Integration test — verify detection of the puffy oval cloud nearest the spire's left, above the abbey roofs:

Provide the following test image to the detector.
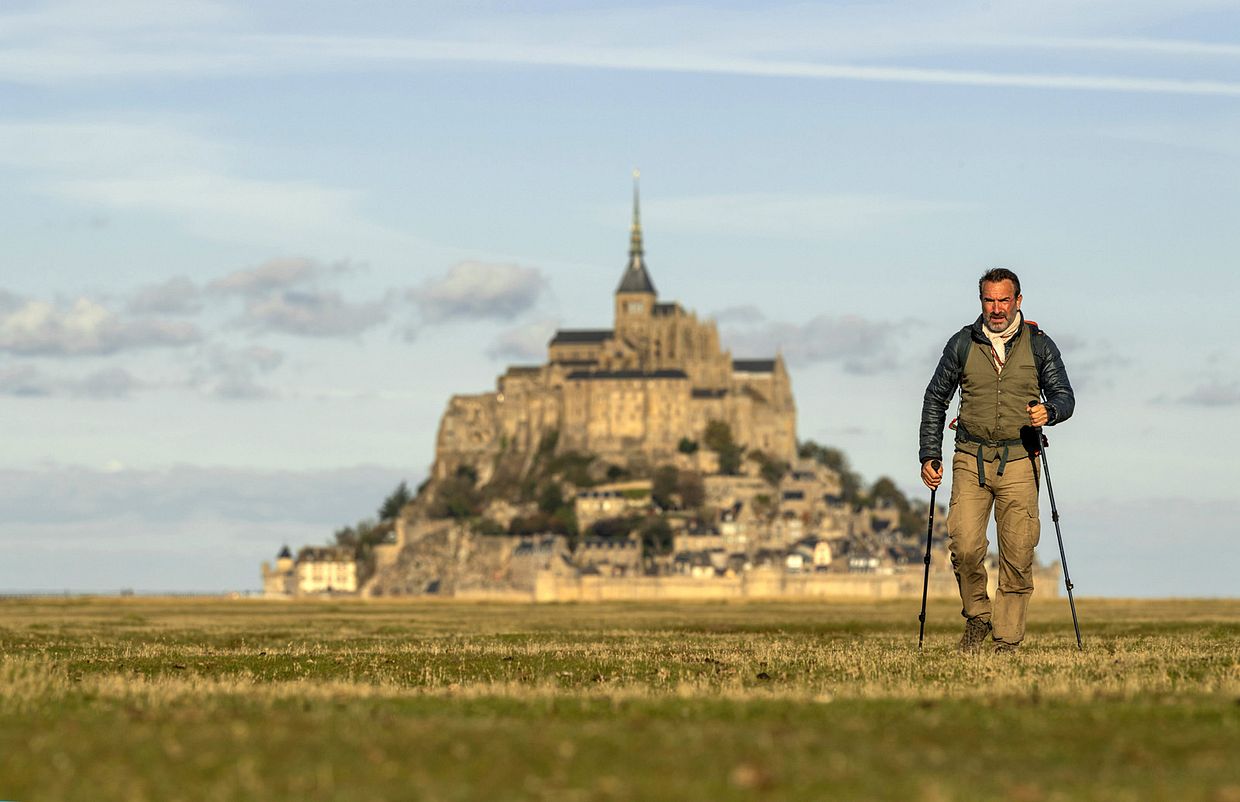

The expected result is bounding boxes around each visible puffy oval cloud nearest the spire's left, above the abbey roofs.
[409,262,547,322]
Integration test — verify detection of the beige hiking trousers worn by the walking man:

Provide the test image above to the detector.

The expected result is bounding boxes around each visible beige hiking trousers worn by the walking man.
[947,451,1042,643]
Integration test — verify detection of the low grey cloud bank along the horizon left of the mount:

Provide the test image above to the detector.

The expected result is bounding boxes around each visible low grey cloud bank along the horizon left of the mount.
[0,466,411,591]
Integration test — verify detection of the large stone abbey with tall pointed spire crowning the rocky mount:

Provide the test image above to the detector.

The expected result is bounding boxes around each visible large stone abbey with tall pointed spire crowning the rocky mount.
[434,178,796,483]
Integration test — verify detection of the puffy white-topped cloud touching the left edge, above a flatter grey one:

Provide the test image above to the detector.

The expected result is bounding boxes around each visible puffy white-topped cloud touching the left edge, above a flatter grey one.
[0,297,201,356]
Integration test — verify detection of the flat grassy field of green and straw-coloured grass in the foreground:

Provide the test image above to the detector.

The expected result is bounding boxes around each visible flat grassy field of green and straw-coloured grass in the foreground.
[0,599,1240,802]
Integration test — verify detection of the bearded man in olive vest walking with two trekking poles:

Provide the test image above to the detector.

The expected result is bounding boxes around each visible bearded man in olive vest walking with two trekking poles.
[919,268,1076,652]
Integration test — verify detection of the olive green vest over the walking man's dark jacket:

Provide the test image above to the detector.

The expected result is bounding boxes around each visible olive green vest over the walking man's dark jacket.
[956,325,1040,461]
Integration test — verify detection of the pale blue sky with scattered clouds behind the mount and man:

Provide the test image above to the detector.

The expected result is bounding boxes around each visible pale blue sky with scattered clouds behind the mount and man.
[0,0,1240,595]
